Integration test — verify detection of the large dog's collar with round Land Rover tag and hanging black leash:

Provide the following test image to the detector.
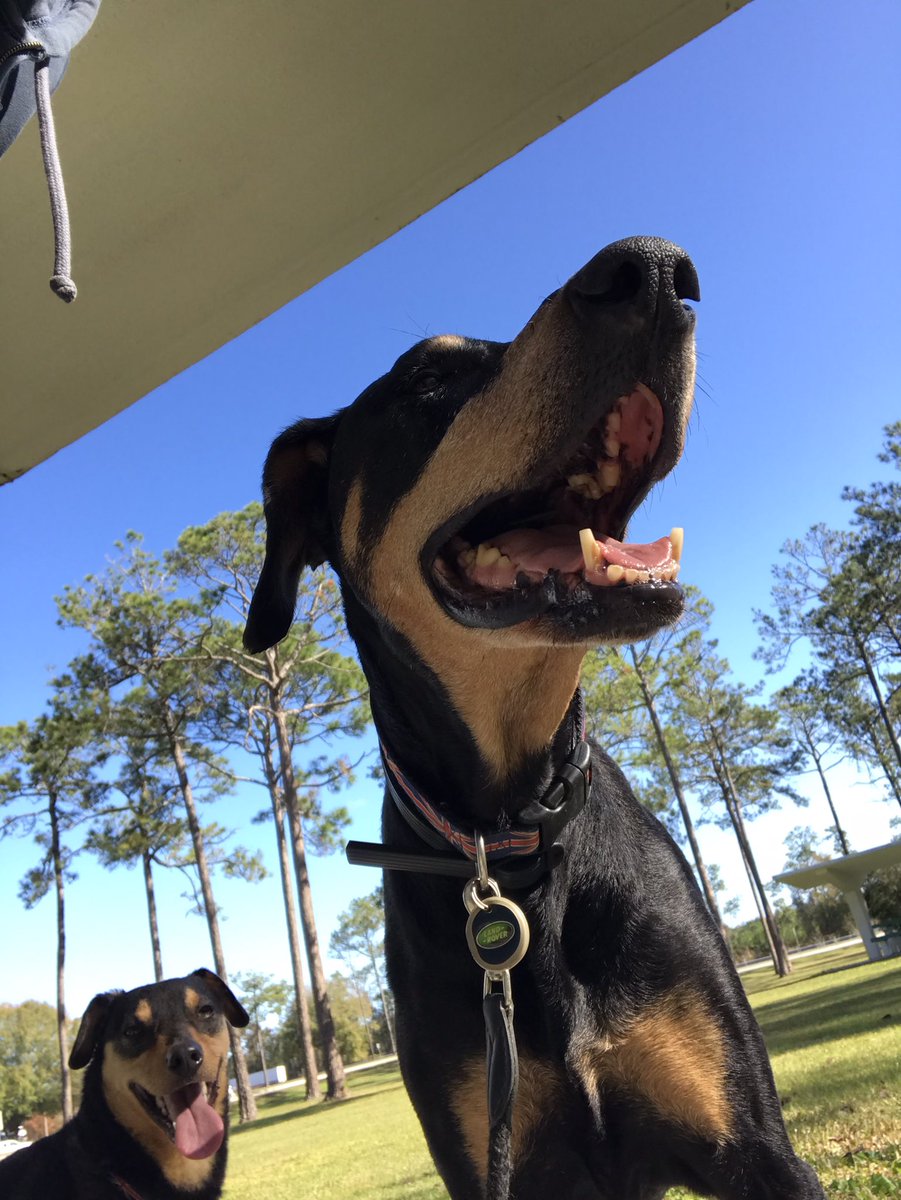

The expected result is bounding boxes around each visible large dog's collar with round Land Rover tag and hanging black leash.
[347,691,591,1200]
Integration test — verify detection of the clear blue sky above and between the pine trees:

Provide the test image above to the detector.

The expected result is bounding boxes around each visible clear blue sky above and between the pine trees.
[0,0,901,1013]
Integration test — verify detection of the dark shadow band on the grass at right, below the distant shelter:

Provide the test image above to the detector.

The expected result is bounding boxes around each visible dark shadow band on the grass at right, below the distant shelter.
[756,968,901,1052]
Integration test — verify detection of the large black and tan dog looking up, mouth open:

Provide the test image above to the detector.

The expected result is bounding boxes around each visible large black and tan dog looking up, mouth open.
[246,238,823,1200]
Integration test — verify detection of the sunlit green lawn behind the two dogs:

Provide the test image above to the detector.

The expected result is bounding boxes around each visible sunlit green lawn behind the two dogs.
[226,948,901,1200]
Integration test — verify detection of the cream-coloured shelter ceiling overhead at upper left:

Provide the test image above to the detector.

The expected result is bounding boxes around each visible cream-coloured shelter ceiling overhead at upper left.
[0,0,744,481]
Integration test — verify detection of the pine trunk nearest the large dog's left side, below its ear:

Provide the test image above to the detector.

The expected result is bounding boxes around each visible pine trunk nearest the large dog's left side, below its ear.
[274,703,347,1100]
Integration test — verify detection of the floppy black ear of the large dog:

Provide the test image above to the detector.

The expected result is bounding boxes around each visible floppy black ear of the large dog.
[244,414,341,654]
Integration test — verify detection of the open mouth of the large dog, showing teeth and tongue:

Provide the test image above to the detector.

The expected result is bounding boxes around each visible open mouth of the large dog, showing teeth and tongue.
[424,383,683,628]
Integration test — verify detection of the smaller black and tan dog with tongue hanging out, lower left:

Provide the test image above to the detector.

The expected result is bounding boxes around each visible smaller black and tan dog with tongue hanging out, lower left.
[0,968,248,1200]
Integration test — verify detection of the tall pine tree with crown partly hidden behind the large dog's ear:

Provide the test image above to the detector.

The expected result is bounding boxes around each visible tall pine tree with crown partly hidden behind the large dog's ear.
[168,504,368,1099]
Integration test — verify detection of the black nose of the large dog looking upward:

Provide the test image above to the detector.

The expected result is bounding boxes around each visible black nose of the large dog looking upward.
[564,238,701,326]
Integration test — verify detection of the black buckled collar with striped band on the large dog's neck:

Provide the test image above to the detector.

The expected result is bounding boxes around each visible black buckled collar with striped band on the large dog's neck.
[347,690,591,888]
